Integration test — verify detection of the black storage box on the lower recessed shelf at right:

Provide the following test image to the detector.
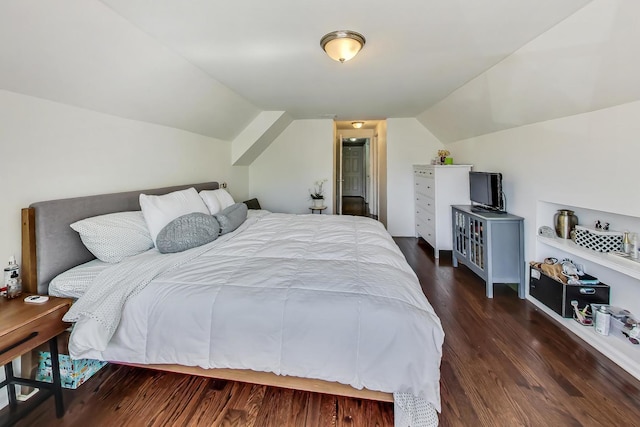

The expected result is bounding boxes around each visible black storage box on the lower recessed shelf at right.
[529,267,610,317]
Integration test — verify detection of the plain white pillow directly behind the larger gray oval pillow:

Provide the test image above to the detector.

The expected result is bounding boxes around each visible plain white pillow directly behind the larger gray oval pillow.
[140,187,209,244]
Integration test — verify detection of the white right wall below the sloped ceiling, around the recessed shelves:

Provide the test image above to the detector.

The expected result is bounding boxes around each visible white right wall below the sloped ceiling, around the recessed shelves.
[447,102,640,313]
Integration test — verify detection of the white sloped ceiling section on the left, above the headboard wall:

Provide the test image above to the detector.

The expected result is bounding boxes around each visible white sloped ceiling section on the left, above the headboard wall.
[0,0,259,140]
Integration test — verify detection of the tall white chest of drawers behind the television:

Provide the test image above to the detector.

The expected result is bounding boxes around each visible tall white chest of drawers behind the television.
[413,165,471,258]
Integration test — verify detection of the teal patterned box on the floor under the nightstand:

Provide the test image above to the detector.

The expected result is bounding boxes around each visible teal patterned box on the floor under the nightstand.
[36,351,107,389]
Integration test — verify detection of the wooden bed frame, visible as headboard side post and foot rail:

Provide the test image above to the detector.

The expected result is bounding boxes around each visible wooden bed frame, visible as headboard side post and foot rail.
[22,185,393,402]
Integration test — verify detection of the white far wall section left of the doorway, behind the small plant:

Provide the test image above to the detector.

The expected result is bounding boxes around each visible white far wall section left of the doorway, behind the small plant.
[249,119,333,213]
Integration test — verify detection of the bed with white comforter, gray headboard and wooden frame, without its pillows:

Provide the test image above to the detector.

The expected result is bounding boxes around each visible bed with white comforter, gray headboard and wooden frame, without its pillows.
[22,182,444,426]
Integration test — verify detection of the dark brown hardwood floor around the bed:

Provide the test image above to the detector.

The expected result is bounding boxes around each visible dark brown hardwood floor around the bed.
[12,238,640,426]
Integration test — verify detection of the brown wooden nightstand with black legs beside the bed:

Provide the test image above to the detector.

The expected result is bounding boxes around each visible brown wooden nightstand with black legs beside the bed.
[0,295,72,425]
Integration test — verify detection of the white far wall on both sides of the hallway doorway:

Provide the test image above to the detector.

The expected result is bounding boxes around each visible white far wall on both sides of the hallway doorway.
[249,118,448,236]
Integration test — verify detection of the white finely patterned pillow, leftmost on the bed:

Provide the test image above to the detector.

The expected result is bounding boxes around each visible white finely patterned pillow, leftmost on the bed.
[71,211,153,263]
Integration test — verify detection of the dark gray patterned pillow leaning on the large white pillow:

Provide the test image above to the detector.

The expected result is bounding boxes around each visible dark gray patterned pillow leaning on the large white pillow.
[156,212,220,254]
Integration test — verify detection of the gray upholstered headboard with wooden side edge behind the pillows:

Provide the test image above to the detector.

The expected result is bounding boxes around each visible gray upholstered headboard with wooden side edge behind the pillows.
[22,182,218,294]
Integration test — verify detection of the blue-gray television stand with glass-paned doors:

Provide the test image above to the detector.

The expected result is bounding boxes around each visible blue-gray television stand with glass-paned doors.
[451,205,526,298]
